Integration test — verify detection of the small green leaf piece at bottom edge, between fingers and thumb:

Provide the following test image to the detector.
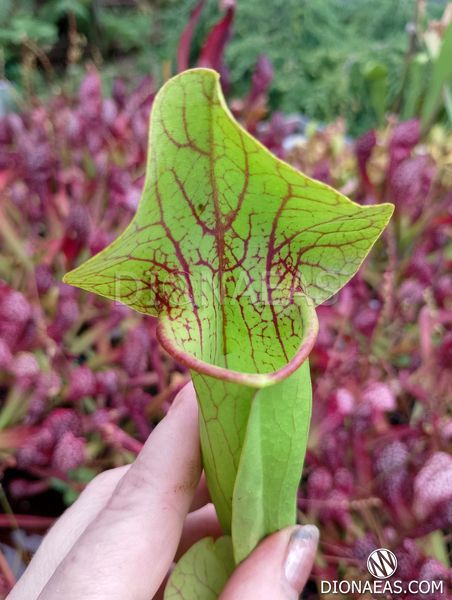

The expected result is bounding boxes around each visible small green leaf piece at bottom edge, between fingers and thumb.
[164,537,234,600]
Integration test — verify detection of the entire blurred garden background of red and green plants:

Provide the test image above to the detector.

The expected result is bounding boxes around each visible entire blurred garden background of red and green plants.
[0,0,452,599]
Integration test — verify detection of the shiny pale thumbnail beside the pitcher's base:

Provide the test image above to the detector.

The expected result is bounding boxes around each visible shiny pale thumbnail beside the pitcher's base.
[284,525,319,593]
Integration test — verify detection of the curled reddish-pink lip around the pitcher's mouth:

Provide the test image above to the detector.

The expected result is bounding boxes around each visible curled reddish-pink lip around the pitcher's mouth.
[157,299,319,388]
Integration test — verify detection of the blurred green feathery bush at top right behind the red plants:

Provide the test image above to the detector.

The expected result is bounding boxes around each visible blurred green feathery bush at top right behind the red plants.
[158,0,445,135]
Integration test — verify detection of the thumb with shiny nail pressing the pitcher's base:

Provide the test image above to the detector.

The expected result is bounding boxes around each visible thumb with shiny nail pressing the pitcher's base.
[220,525,319,600]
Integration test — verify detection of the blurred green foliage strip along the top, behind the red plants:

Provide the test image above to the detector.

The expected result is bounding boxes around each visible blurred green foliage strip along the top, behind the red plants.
[0,0,450,135]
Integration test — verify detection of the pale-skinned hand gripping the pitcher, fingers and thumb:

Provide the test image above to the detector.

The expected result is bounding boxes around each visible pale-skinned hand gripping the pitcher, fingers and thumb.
[7,384,318,600]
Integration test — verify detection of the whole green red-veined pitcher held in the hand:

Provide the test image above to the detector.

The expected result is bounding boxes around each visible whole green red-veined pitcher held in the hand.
[65,69,392,600]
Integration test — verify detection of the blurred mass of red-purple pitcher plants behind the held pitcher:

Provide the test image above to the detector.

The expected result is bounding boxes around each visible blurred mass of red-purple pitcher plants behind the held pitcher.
[0,24,452,596]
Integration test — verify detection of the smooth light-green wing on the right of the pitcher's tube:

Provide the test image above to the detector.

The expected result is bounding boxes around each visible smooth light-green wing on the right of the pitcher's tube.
[232,360,312,563]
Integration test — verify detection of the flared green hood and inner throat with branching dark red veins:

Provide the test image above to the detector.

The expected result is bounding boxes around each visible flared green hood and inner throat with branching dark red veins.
[66,69,392,380]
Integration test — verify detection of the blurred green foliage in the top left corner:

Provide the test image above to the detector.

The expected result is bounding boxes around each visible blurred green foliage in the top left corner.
[0,0,162,95]
